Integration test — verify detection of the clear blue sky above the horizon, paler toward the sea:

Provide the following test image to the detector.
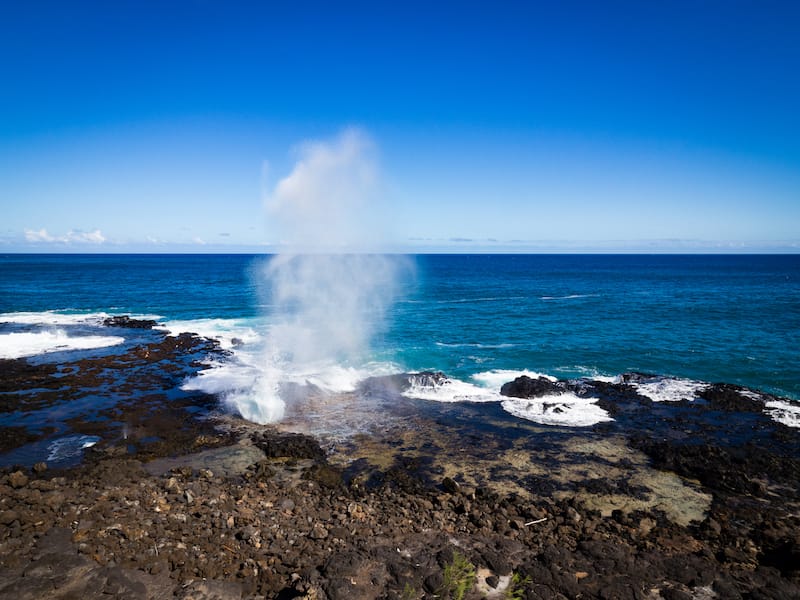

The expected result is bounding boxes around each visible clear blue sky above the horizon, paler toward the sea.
[0,0,800,252]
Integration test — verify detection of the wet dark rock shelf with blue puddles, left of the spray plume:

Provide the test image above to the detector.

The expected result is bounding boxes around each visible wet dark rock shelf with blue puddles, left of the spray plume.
[0,326,231,465]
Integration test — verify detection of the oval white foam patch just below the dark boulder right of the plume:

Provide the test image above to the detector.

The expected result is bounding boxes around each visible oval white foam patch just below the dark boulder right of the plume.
[502,392,613,427]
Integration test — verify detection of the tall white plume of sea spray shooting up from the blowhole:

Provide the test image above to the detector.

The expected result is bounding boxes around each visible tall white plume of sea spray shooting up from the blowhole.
[229,129,410,422]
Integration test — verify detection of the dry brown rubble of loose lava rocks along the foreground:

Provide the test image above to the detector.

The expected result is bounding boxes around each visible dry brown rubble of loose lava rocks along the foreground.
[0,418,800,599]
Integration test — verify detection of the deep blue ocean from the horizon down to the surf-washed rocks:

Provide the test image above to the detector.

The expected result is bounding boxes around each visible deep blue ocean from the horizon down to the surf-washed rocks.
[0,255,800,432]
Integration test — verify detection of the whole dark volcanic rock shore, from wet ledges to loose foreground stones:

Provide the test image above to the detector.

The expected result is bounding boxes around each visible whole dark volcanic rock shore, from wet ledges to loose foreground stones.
[0,321,800,600]
